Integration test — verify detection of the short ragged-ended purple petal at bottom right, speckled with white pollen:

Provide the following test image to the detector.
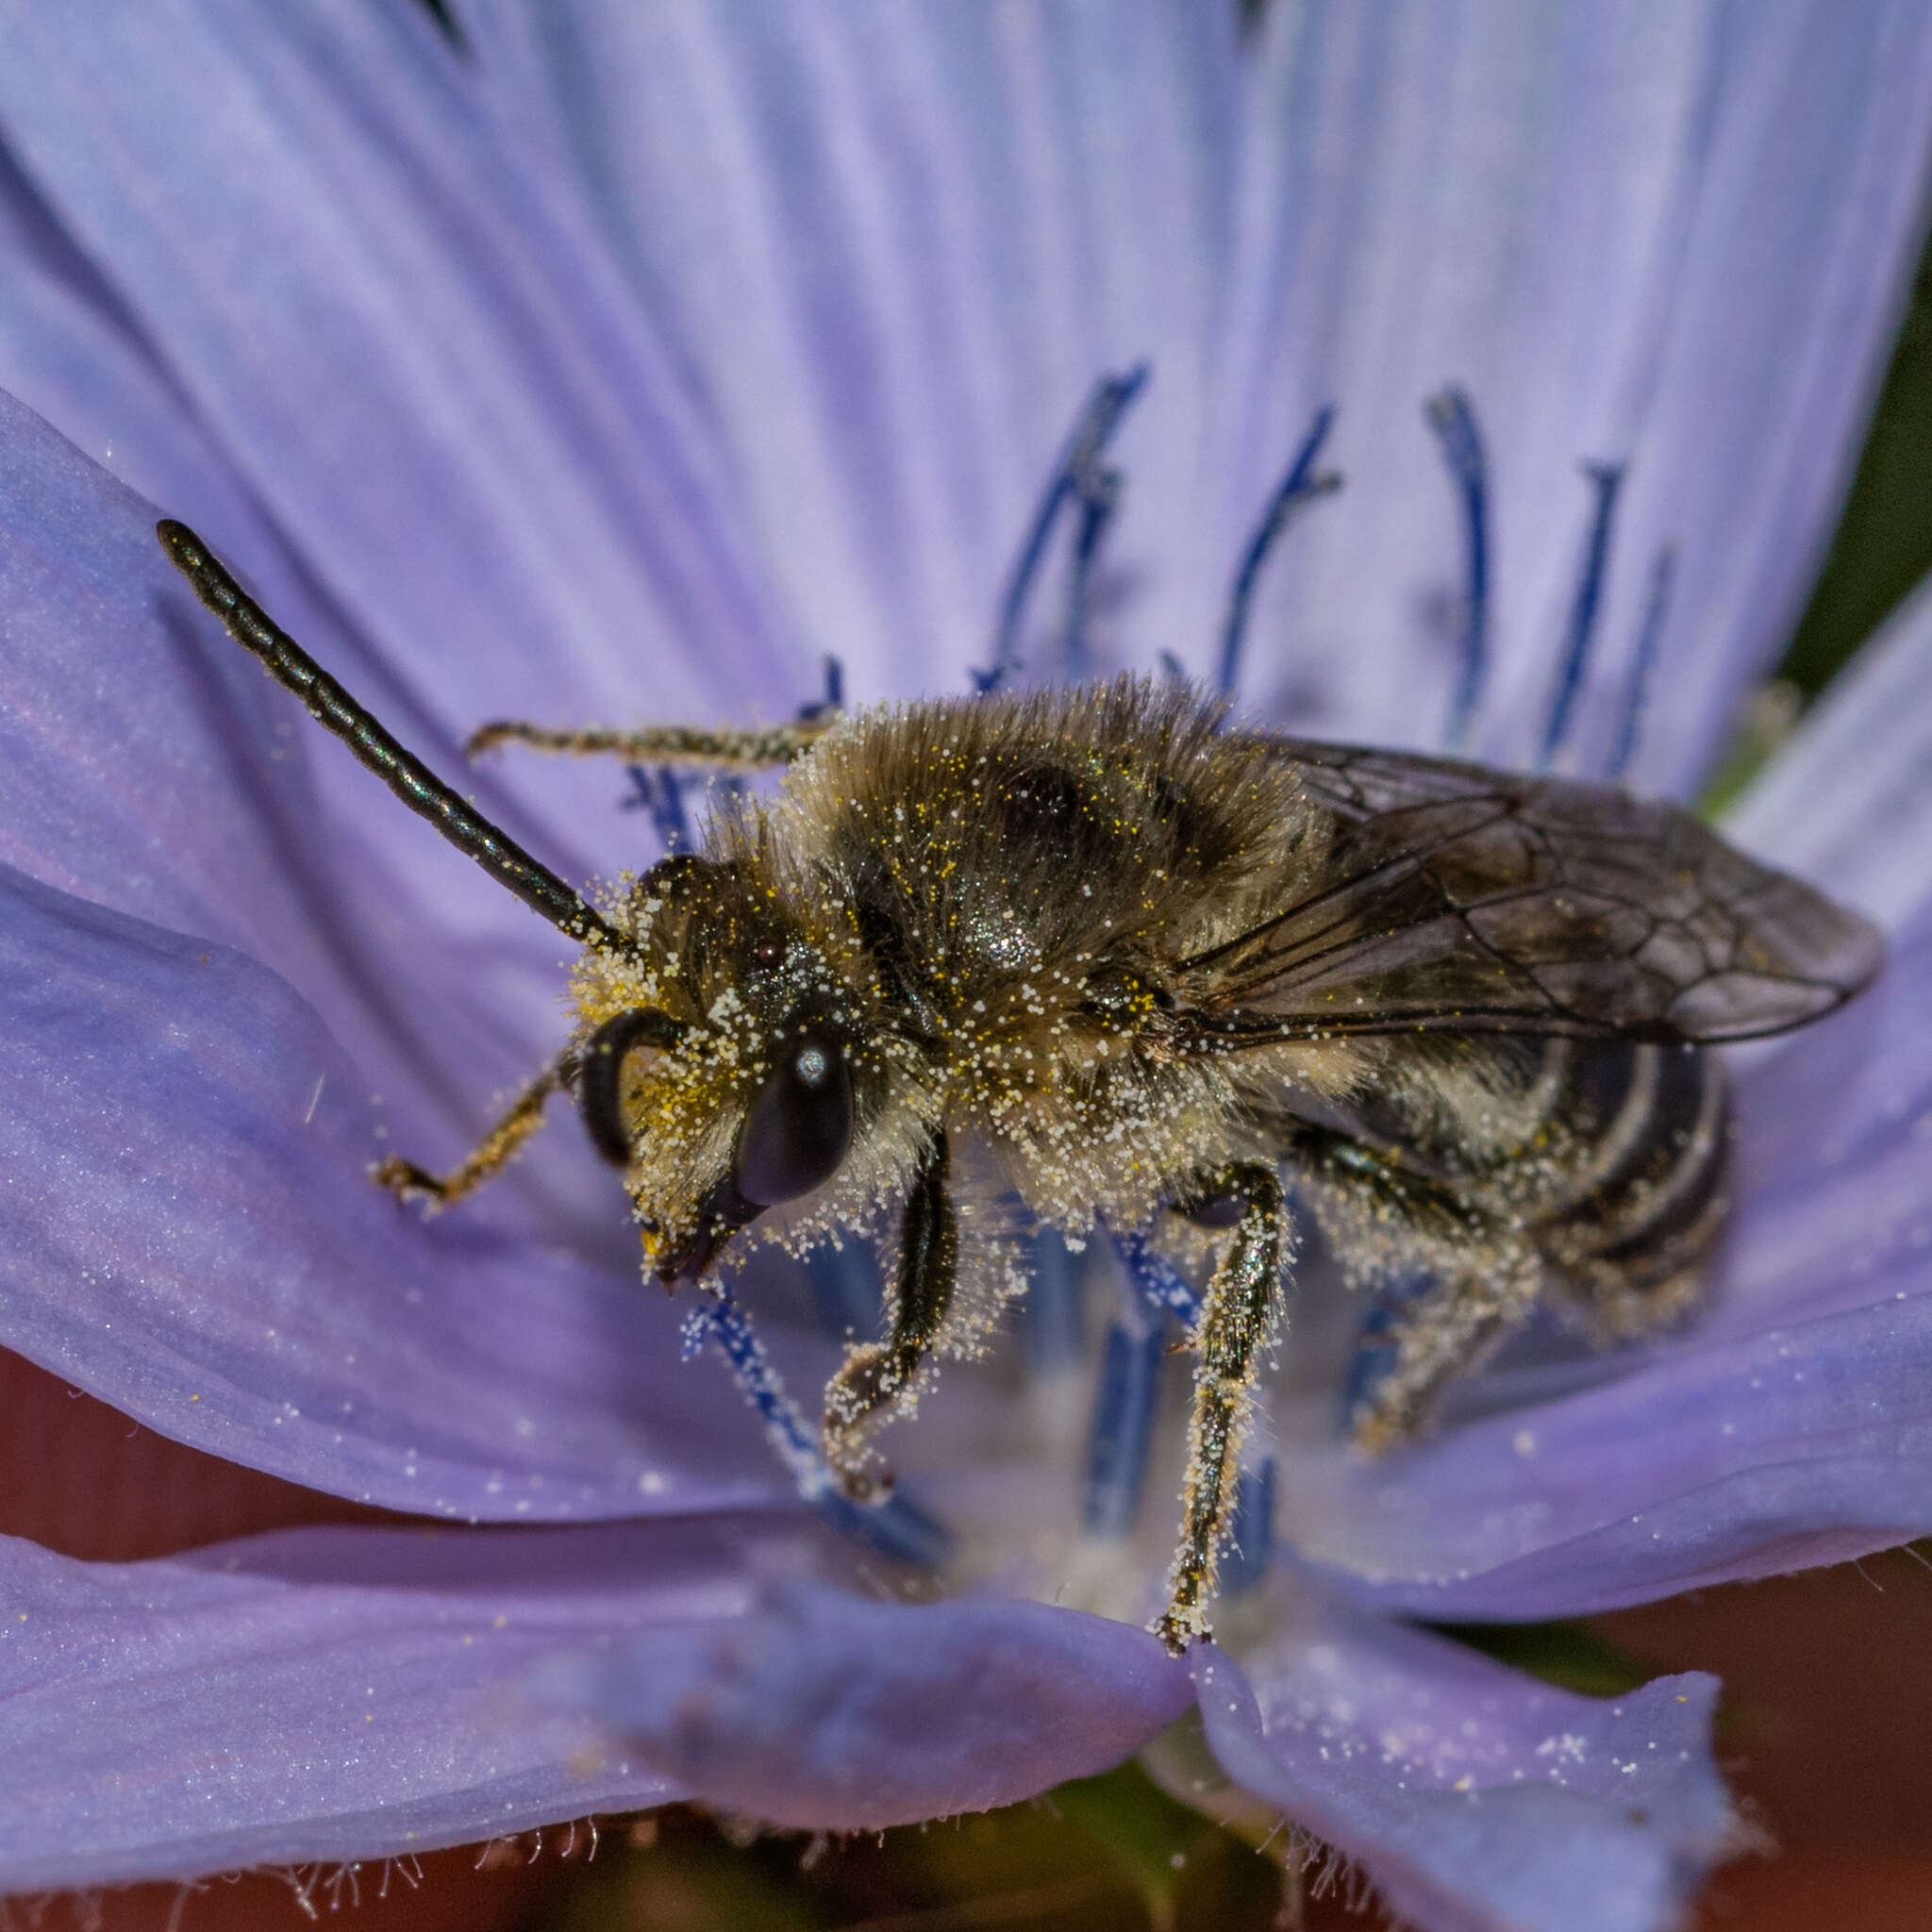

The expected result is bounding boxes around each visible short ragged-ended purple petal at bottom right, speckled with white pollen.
[1194,1611,1731,1932]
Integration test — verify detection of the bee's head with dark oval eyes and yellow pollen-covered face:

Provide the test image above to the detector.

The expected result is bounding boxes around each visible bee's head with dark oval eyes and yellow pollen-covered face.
[574,854,854,1287]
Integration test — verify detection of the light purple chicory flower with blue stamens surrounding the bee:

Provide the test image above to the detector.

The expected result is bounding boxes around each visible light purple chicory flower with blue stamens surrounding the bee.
[0,0,1932,1932]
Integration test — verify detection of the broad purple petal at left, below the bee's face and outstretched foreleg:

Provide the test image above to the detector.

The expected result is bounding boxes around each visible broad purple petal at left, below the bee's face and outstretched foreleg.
[0,872,782,1521]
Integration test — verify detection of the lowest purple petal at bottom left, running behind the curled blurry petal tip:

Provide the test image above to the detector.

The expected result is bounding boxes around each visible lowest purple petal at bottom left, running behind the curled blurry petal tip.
[0,1523,791,1893]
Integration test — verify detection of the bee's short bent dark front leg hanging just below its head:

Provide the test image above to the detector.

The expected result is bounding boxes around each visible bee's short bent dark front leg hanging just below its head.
[821,1128,960,1501]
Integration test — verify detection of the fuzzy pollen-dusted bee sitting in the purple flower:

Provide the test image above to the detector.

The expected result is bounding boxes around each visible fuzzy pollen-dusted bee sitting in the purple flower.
[158,522,1882,1654]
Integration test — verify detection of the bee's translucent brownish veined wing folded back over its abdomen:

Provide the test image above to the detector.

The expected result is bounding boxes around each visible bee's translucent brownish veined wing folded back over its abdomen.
[1182,738,1884,1045]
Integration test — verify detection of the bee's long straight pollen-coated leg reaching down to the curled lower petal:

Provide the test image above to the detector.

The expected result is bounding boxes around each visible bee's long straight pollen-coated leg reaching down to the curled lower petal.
[1154,1163,1289,1657]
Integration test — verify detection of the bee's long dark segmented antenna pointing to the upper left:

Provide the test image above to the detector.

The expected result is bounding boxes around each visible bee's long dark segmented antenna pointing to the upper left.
[155,518,628,951]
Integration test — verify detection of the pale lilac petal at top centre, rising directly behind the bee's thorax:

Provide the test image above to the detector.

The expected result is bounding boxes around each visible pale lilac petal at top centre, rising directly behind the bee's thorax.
[466,0,1239,701]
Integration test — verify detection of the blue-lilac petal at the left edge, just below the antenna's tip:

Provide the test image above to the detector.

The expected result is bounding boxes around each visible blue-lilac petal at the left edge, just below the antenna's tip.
[0,394,359,1042]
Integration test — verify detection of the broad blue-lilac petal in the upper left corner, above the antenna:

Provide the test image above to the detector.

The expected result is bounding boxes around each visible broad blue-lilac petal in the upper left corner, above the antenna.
[0,0,799,738]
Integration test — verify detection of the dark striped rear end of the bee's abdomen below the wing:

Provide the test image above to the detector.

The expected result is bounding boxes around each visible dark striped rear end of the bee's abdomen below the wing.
[1532,1045,1731,1335]
